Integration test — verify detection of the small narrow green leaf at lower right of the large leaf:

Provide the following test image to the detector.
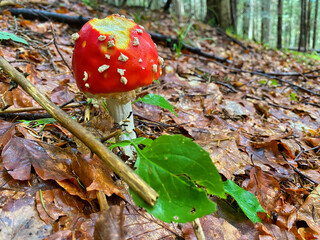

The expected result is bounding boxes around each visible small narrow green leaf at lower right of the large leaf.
[224,180,266,223]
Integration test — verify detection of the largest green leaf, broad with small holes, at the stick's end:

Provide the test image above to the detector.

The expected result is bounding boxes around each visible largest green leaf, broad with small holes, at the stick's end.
[131,135,225,223]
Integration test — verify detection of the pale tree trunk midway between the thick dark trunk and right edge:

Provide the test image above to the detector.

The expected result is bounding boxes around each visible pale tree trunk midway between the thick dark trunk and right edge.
[261,1,271,43]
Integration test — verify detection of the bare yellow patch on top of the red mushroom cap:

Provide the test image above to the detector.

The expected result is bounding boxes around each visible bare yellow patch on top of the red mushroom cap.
[90,15,136,49]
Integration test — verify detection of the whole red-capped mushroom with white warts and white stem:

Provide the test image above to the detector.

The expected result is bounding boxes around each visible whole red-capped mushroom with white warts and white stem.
[72,14,163,158]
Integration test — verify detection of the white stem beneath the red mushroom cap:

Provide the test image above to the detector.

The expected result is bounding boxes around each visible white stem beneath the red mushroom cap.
[106,98,137,159]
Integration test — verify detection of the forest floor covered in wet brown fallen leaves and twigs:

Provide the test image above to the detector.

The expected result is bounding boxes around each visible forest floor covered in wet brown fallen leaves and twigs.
[0,0,320,239]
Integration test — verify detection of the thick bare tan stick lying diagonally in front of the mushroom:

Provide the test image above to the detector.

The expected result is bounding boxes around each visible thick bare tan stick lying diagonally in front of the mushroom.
[0,56,158,206]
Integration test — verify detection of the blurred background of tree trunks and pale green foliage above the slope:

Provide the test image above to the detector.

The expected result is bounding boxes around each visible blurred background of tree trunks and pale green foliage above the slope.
[99,0,320,51]
